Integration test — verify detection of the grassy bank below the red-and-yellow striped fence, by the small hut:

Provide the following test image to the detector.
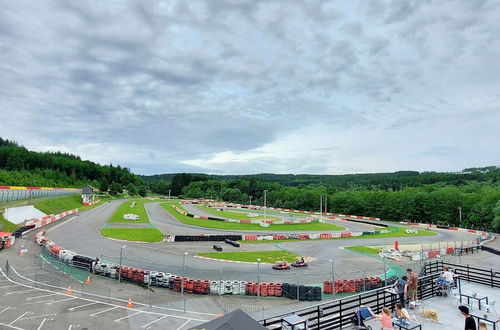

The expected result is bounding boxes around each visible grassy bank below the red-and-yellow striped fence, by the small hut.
[33,194,113,214]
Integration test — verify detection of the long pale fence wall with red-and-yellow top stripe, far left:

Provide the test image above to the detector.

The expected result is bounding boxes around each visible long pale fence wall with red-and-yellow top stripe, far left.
[0,186,82,203]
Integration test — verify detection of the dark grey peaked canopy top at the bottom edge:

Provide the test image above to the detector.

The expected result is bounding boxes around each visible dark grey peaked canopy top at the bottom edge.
[191,309,267,330]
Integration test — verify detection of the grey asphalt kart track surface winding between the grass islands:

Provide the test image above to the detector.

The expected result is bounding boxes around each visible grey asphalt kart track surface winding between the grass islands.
[41,200,478,283]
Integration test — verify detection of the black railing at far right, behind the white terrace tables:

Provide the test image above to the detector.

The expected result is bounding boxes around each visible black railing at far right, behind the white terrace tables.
[423,260,500,288]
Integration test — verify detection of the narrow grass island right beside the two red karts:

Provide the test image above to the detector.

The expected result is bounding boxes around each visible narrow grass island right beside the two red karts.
[198,251,299,263]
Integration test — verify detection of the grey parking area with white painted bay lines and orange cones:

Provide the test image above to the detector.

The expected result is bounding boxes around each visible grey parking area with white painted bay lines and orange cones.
[0,275,213,330]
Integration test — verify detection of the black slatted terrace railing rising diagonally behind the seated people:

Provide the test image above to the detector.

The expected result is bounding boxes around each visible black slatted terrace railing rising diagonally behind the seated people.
[259,272,444,330]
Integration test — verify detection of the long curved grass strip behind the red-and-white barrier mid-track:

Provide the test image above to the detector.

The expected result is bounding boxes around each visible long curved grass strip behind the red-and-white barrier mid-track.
[160,203,344,231]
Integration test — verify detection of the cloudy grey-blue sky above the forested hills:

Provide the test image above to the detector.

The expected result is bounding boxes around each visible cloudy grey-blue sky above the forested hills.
[0,0,500,174]
